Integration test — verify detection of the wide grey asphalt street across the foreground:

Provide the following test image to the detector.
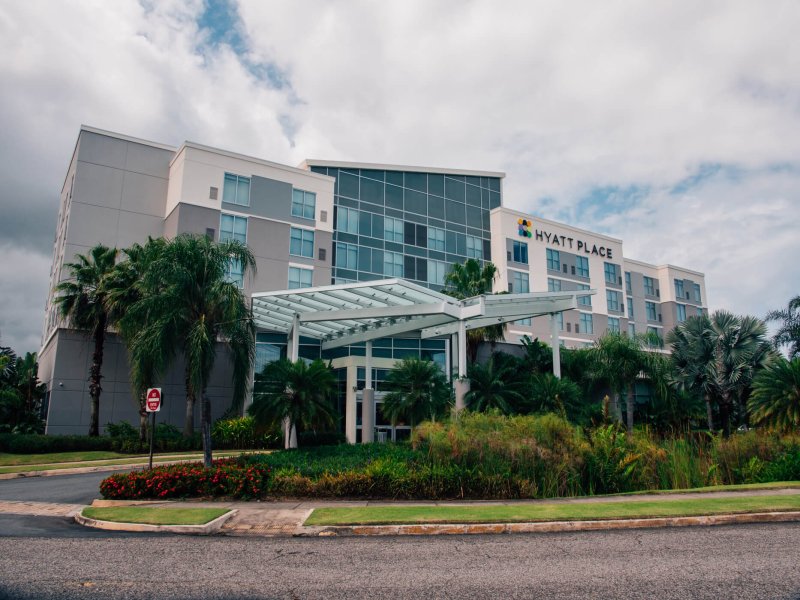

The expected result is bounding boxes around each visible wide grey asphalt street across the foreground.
[0,524,800,600]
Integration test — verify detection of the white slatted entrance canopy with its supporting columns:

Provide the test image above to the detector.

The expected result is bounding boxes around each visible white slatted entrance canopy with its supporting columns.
[252,279,595,441]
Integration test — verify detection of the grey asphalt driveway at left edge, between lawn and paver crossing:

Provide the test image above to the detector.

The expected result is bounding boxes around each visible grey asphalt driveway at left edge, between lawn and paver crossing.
[0,471,122,504]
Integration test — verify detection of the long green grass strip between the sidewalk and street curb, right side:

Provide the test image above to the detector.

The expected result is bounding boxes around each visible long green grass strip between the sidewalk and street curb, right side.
[305,494,800,525]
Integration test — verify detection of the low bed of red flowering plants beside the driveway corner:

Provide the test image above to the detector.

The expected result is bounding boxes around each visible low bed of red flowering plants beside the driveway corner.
[100,458,271,500]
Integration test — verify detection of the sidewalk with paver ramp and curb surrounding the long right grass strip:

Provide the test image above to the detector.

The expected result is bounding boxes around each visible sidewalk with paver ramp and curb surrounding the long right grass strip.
[65,488,800,537]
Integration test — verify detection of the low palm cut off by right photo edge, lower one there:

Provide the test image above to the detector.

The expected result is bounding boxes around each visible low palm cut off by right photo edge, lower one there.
[747,356,800,430]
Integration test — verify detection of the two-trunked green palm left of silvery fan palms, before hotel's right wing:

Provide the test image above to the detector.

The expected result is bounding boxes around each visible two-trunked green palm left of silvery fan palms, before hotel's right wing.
[594,332,648,436]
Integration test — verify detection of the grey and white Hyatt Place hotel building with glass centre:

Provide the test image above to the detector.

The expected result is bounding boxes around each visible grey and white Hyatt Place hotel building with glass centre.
[39,127,706,441]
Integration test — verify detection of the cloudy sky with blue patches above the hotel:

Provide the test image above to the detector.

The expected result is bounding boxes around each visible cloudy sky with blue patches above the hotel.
[0,0,800,352]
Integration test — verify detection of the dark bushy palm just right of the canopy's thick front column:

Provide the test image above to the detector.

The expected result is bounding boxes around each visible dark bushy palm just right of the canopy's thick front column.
[465,352,524,415]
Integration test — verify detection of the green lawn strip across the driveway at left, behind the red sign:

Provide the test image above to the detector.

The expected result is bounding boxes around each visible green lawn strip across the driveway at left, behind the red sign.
[0,450,253,473]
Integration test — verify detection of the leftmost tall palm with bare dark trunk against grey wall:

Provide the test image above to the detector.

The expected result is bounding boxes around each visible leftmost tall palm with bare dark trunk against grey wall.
[55,245,117,436]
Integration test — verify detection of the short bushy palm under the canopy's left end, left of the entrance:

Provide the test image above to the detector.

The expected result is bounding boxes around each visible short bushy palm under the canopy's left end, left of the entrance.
[248,358,336,447]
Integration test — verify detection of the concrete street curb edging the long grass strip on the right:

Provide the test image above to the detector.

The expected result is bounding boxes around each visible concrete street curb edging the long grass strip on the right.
[294,511,800,537]
